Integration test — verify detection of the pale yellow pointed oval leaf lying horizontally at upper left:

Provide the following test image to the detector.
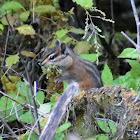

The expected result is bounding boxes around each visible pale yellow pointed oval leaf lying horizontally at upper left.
[16,25,35,35]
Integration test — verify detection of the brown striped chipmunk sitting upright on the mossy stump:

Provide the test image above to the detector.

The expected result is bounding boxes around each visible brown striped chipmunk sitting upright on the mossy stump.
[42,40,102,92]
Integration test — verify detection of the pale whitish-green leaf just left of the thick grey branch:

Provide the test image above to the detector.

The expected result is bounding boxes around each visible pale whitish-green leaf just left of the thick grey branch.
[38,103,52,114]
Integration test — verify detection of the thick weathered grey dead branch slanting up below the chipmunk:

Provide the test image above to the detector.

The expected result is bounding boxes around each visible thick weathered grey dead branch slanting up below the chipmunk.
[39,83,78,140]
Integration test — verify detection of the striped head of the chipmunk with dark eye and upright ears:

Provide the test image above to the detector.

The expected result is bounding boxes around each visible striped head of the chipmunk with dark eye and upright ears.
[42,40,72,67]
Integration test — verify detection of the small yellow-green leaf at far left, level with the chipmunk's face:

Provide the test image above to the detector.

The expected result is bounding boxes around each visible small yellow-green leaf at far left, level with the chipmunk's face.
[6,54,19,67]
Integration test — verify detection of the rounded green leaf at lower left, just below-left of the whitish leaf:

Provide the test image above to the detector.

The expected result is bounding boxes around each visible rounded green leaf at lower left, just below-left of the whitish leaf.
[20,111,33,124]
